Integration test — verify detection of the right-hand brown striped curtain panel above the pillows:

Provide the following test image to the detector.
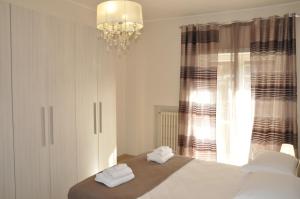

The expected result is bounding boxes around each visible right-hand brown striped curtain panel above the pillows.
[250,15,298,157]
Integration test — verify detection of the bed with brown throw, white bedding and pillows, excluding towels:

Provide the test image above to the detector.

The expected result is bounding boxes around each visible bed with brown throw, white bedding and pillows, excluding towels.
[68,152,300,199]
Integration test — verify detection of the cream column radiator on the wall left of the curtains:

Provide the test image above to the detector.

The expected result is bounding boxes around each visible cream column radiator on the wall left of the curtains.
[158,111,178,151]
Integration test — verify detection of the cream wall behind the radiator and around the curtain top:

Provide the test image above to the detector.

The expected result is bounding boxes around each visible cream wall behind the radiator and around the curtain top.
[119,2,300,155]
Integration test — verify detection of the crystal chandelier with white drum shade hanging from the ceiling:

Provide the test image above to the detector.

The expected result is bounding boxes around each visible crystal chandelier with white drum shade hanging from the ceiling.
[97,0,143,50]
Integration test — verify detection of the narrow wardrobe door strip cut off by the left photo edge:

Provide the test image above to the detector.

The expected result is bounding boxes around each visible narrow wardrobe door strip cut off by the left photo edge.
[0,2,15,199]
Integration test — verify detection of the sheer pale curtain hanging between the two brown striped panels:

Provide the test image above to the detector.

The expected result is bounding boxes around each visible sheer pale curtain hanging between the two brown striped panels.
[216,23,253,165]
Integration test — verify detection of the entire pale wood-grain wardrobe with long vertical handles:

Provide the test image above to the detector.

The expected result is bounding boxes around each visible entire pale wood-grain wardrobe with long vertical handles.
[0,3,116,199]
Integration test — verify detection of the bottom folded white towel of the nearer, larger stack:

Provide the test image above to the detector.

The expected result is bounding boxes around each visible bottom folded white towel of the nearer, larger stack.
[95,172,134,188]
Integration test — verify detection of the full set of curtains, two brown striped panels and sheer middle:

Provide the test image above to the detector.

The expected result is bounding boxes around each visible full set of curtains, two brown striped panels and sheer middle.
[178,15,298,165]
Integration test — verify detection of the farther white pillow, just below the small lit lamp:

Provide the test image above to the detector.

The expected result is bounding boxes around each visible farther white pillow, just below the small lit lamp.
[242,151,298,175]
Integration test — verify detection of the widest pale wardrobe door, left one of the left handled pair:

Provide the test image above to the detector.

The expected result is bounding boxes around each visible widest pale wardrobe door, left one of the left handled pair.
[11,6,50,199]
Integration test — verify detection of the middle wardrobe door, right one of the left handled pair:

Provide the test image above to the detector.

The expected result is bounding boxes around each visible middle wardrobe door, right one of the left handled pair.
[48,17,77,199]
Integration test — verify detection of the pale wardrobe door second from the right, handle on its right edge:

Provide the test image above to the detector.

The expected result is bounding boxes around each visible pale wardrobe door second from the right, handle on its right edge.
[75,25,99,181]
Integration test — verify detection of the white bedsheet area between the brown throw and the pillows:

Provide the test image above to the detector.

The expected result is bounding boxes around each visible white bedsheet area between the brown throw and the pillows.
[139,160,246,199]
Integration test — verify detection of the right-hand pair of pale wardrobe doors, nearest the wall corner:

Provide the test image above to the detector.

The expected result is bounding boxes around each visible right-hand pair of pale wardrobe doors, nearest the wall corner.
[75,25,117,180]
